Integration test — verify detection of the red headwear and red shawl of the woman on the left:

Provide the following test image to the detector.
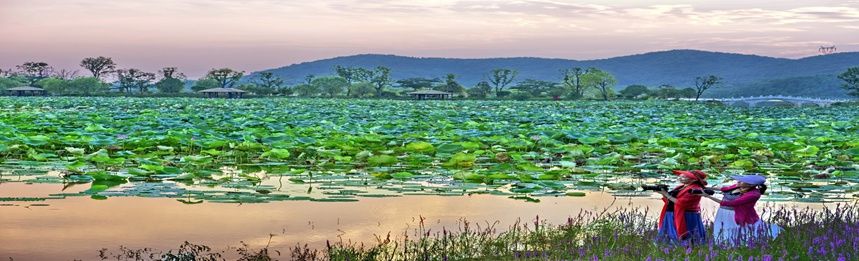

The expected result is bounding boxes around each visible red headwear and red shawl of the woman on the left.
[659,170,707,238]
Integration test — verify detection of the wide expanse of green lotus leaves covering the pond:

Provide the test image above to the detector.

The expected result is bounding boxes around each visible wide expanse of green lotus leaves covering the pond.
[0,98,859,206]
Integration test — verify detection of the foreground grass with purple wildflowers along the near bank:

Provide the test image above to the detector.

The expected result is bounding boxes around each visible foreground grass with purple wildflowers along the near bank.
[95,204,859,261]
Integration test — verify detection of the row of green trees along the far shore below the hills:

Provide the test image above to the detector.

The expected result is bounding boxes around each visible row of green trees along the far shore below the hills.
[0,56,859,100]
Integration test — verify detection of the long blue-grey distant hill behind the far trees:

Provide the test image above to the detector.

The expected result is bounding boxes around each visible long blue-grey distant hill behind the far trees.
[251,50,859,97]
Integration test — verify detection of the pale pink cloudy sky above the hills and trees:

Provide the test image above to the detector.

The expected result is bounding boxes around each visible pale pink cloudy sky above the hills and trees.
[0,0,859,78]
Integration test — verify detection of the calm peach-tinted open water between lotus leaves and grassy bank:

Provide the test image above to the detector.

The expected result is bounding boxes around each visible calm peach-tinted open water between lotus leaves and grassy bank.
[0,183,832,260]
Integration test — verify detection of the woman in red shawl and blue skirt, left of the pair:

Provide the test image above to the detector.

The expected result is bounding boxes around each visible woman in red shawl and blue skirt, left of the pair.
[657,170,707,243]
